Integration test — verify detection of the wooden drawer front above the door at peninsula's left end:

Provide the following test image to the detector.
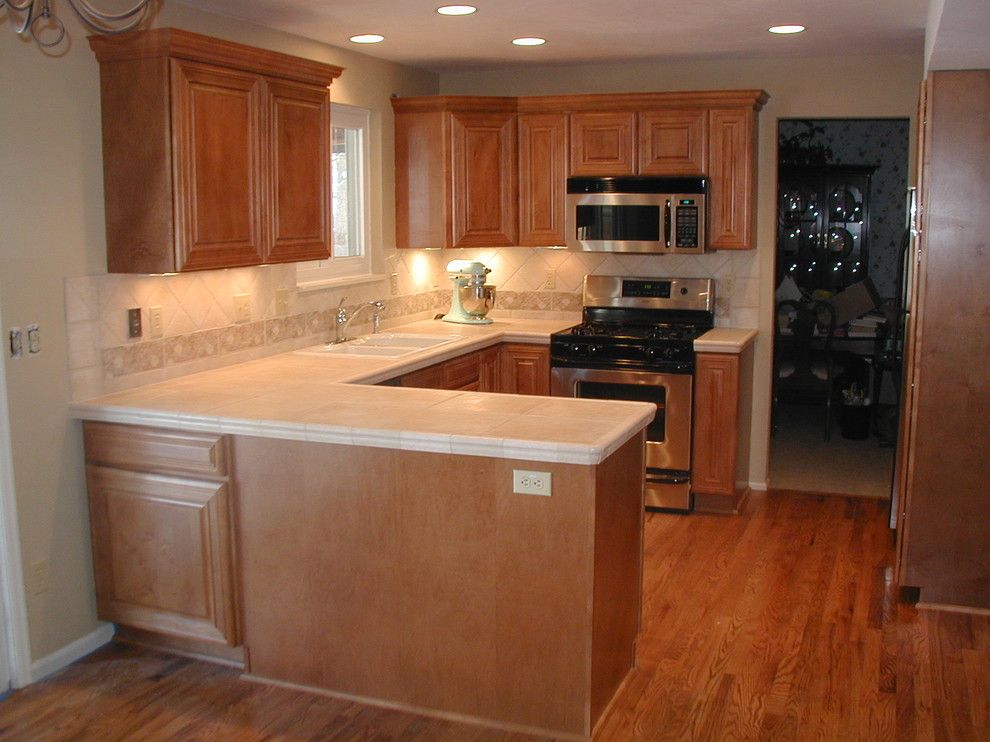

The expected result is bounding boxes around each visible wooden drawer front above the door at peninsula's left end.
[83,422,227,477]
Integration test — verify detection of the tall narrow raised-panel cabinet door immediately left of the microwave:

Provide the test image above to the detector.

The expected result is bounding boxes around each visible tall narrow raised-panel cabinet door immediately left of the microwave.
[517,113,567,247]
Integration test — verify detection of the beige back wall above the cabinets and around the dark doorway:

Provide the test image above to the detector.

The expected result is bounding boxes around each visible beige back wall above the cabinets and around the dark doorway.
[440,52,924,483]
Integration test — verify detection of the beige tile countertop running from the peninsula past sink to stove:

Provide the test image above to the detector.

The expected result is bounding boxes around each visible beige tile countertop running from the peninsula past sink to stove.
[71,319,655,465]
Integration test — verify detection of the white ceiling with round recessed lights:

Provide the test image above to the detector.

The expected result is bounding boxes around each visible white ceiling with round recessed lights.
[174,0,932,72]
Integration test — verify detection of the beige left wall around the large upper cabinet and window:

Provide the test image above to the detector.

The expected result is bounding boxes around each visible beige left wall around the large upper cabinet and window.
[0,3,438,660]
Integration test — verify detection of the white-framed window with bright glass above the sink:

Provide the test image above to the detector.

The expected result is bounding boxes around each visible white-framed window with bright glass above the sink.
[296,103,371,287]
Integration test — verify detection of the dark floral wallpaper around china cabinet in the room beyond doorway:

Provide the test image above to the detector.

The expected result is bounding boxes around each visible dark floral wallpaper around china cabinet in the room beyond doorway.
[778,119,909,298]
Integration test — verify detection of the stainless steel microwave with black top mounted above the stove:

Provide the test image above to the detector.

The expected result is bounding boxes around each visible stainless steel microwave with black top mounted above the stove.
[564,176,708,255]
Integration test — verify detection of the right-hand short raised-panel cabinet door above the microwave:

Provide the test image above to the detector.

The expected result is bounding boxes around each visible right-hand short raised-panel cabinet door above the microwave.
[639,109,708,175]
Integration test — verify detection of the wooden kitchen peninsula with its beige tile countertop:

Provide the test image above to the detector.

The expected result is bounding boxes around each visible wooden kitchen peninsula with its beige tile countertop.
[73,320,654,739]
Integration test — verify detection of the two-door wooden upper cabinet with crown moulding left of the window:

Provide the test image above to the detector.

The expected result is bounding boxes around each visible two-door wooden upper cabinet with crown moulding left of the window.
[89,29,341,273]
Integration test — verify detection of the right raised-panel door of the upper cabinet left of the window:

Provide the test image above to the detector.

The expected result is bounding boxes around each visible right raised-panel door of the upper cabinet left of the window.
[265,80,330,262]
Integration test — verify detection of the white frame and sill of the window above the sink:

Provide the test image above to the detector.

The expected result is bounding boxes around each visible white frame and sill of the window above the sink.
[296,103,381,289]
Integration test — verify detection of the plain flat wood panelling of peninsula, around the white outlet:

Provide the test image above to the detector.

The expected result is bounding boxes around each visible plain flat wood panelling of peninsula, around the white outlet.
[233,434,644,738]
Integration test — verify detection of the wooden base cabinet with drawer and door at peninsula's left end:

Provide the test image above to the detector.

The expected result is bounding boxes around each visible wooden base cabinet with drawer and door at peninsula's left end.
[84,422,239,659]
